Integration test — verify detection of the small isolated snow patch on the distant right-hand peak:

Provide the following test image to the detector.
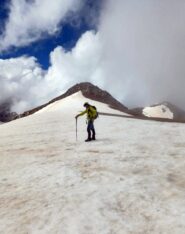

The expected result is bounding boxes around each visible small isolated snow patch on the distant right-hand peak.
[143,105,173,119]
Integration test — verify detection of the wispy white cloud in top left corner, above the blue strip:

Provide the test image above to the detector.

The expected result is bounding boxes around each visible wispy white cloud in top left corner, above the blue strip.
[0,0,82,51]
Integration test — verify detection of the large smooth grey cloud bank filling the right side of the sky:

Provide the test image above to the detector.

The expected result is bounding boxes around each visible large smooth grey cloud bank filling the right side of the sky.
[99,0,185,108]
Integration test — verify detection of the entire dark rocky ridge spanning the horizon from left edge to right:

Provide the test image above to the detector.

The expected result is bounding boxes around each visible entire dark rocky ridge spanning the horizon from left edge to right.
[0,82,185,123]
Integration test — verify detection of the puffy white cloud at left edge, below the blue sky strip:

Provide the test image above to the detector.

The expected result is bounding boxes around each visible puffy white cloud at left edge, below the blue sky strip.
[0,56,48,112]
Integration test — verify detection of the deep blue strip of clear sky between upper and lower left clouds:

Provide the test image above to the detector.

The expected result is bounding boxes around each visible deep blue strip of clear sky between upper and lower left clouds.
[0,23,93,69]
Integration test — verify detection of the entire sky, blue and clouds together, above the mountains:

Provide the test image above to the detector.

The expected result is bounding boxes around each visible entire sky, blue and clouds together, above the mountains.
[0,0,185,113]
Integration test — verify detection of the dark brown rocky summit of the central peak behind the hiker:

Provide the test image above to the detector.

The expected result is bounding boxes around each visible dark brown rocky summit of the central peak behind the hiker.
[16,82,129,118]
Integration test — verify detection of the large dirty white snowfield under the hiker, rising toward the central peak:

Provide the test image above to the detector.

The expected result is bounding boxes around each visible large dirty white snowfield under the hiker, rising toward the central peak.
[0,93,185,234]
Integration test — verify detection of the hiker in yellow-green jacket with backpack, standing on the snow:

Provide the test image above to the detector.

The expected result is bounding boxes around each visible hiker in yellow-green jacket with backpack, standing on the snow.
[75,102,97,142]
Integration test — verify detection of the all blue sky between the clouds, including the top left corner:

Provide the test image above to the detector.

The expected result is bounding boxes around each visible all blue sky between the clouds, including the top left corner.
[0,0,102,69]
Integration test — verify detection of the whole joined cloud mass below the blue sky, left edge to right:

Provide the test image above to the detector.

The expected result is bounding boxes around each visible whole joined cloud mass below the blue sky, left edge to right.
[0,0,185,112]
